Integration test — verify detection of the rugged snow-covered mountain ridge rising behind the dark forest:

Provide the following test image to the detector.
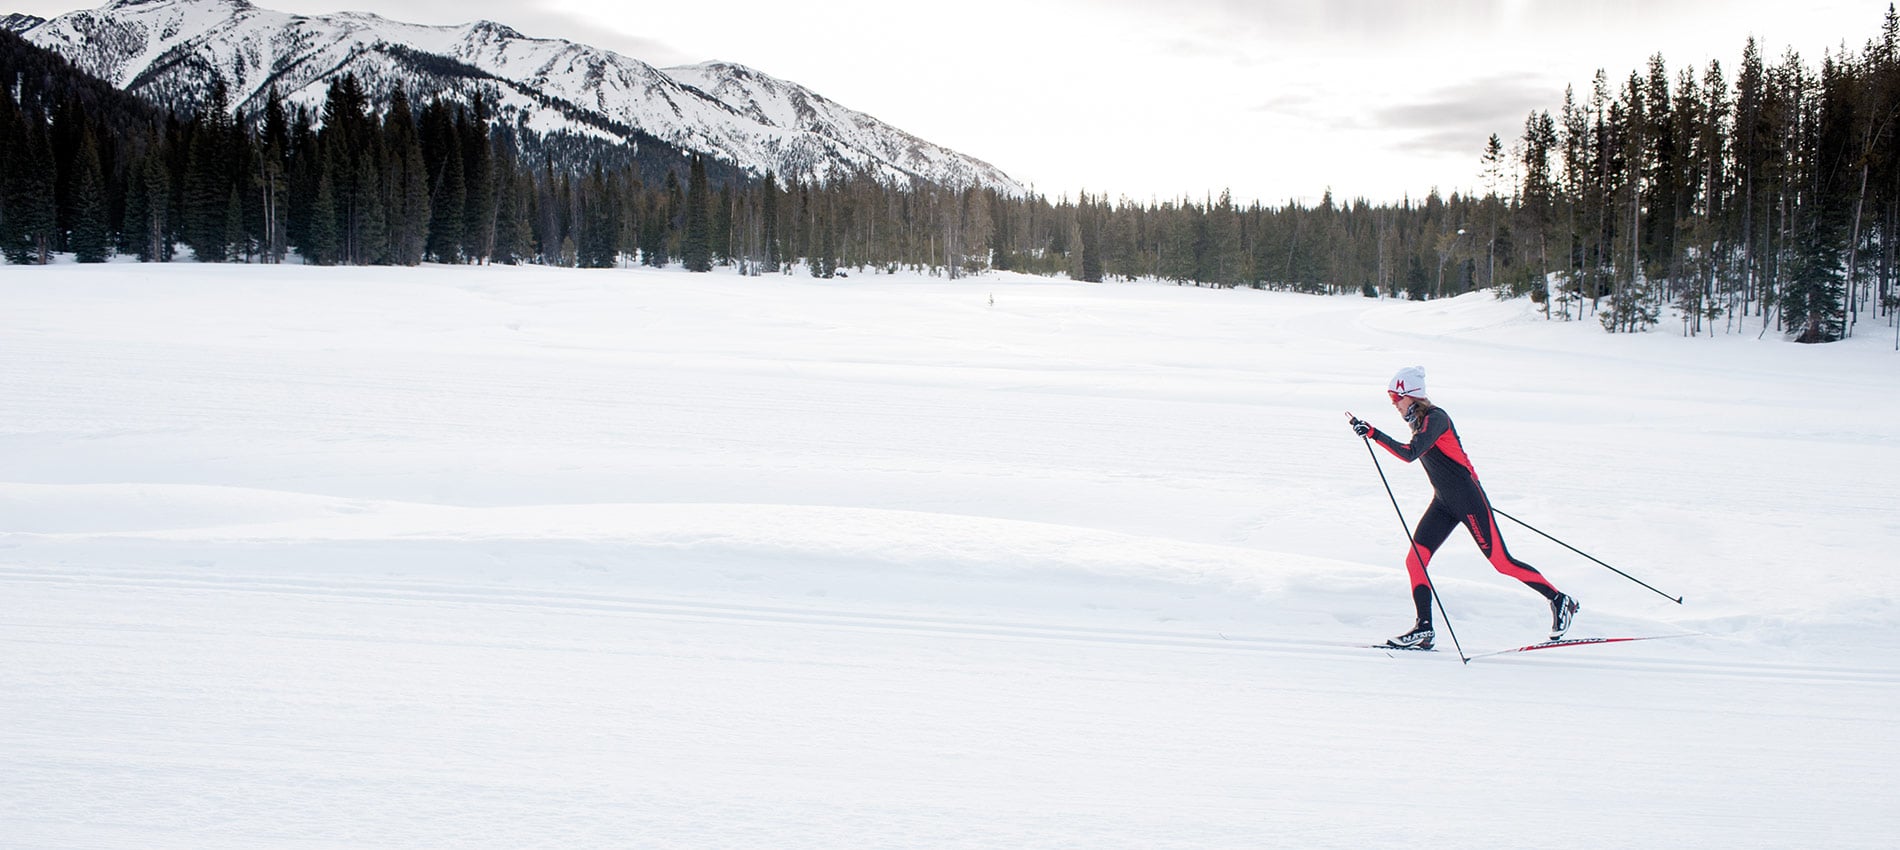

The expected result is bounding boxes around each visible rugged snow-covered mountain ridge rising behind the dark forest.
[6,0,1022,194]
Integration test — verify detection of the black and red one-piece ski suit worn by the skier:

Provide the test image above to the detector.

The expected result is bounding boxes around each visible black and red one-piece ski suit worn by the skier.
[1372,403,1558,626]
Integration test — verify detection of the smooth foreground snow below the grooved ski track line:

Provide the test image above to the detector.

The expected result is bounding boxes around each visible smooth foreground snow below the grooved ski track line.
[0,569,1900,848]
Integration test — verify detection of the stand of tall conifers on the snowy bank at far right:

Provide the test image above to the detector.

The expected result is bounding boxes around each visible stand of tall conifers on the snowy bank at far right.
[1489,6,1900,342]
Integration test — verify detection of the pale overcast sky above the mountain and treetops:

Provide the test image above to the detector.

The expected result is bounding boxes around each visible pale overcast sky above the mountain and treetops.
[14,0,1889,203]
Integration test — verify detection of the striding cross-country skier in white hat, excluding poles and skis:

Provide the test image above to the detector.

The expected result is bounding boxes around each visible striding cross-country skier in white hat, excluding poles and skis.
[1349,365,1577,648]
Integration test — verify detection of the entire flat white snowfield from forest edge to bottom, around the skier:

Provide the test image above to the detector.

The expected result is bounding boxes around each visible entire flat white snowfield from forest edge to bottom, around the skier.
[0,264,1900,850]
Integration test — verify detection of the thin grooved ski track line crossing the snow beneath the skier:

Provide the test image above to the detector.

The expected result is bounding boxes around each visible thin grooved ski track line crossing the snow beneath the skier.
[0,567,1900,685]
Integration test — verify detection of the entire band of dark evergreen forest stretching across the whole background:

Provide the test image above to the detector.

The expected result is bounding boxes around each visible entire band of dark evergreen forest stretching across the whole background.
[0,8,1900,342]
